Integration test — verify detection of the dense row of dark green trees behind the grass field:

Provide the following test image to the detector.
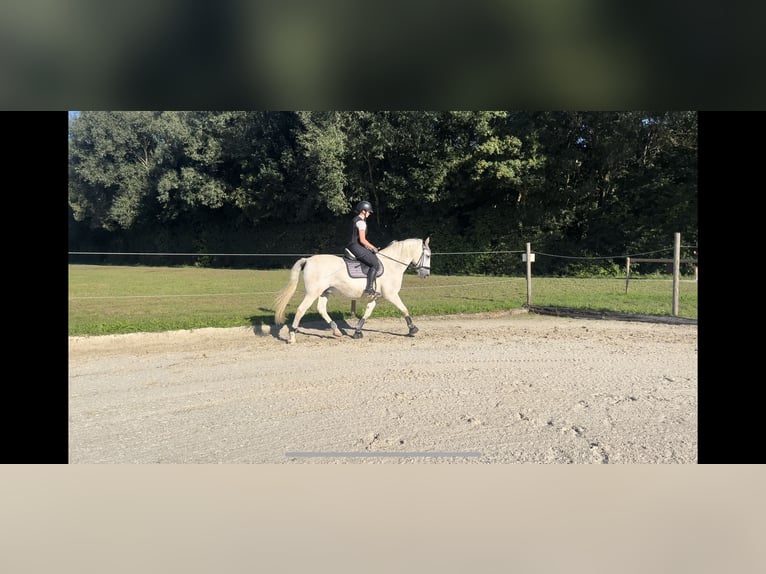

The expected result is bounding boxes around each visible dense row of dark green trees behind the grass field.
[68,111,698,274]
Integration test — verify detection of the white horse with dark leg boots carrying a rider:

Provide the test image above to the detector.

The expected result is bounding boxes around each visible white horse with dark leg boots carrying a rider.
[274,238,431,343]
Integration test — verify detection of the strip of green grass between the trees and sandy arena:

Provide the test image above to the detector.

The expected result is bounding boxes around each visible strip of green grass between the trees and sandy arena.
[69,265,697,336]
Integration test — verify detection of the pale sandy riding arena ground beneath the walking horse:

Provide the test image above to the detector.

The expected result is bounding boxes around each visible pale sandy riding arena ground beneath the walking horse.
[69,313,697,464]
